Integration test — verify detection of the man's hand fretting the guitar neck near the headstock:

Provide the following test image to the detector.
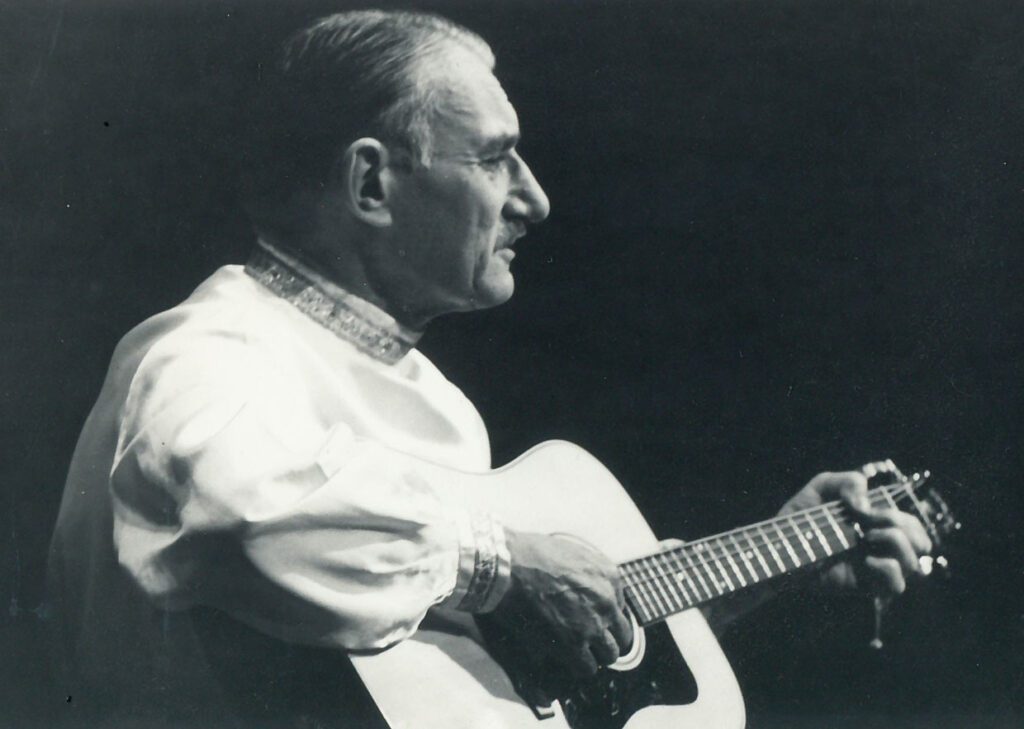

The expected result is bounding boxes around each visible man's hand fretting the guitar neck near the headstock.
[779,461,932,598]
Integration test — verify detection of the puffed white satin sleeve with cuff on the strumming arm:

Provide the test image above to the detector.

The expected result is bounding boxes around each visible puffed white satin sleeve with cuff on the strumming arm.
[111,329,509,649]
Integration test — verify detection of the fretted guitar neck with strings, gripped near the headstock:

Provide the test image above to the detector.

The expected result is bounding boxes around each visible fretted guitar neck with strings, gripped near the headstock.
[620,482,918,626]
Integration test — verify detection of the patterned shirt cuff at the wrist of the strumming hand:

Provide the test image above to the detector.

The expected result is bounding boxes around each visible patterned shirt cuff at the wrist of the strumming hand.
[444,514,512,613]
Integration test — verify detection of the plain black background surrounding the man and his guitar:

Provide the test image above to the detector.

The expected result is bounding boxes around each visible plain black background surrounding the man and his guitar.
[0,0,1024,728]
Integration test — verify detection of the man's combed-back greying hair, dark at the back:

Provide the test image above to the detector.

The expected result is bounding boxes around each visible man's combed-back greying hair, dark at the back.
[243,10,495,239]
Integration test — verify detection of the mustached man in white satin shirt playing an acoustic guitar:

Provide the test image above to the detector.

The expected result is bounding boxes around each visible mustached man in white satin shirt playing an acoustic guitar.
[51,11,930,727]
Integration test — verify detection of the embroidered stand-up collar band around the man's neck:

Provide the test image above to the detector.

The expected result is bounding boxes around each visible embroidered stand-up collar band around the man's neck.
[246,240,422,365]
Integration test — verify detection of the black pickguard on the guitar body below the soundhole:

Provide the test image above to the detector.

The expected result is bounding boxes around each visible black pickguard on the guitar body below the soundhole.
[559,625,697,729]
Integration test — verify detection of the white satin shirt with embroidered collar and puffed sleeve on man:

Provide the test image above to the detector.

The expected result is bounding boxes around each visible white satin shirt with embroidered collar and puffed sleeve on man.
[51,244,508,724]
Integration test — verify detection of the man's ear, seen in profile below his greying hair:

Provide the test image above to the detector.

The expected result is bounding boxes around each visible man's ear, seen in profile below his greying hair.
[336,137,391,227]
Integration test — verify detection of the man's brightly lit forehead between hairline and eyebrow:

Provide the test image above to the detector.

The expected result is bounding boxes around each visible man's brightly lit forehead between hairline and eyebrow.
[419,52,519,155]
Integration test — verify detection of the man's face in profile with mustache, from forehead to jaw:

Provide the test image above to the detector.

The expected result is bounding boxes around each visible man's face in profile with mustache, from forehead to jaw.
[378,51,549,324]
